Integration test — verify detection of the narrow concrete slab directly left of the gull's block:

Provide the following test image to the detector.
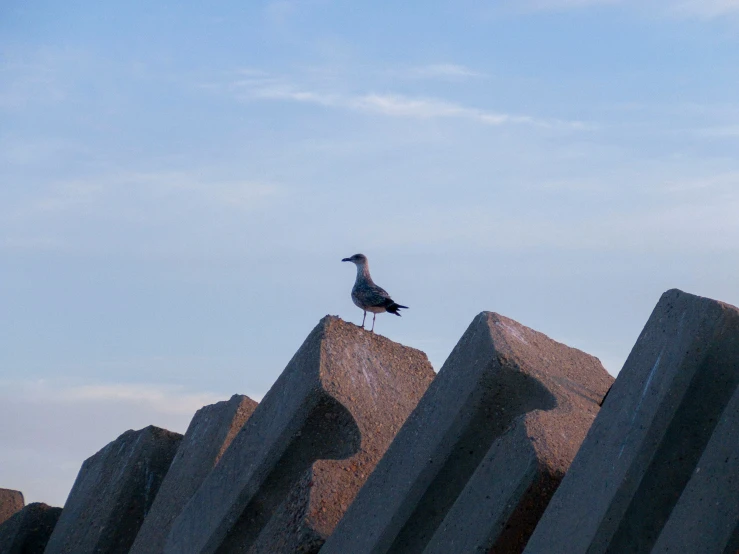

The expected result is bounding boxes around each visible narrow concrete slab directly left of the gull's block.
[130,394,257,554]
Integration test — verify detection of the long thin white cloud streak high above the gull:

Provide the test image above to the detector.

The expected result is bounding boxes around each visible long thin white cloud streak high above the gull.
[228,76,586,129]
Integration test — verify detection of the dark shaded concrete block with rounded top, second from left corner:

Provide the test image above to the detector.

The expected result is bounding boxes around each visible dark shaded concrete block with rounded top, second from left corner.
[46,425,182,554]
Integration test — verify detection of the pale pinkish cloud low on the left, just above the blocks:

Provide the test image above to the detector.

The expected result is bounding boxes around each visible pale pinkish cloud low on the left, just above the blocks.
[0,380,260,506]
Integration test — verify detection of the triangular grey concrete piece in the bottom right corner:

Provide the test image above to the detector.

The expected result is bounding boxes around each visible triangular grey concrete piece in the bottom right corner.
[652,378,739,554]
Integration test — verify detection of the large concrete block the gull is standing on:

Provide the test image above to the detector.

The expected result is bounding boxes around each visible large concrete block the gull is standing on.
[165,316,434,554]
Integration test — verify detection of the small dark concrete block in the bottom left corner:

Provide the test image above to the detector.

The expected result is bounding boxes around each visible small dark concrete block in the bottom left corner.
[0,502,62,554]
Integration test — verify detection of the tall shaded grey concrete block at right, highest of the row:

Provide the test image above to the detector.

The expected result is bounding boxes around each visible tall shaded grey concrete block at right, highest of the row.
[525,290,739,554]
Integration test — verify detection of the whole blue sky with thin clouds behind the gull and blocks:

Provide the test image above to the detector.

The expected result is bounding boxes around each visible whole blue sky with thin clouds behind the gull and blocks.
[0,0,739,505]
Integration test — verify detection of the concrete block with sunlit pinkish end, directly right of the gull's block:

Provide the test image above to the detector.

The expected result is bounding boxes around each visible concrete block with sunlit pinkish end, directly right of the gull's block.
[321,312,613,554]
